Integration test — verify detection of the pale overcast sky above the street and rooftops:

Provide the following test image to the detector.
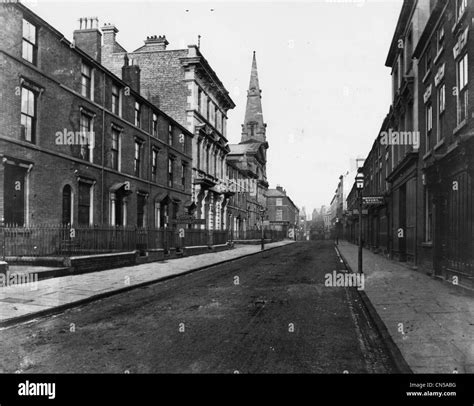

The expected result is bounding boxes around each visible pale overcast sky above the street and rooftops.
[24,0,402,219]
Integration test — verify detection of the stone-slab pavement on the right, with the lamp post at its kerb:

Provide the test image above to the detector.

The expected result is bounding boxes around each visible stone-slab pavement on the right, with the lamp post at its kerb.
[338,241,474,373]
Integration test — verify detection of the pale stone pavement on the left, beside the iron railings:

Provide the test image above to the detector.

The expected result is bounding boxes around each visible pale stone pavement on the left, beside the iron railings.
[0,240,294,326]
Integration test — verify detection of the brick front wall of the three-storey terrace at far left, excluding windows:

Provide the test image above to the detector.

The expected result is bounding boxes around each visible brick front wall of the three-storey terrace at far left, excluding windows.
[0,5,192,225]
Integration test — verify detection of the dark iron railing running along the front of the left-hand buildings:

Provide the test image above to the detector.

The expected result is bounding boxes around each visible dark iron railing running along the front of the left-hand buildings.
[0,225,285,258]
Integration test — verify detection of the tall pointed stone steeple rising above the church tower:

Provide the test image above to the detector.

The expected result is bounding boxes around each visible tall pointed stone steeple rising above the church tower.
[241,51,267,143]
